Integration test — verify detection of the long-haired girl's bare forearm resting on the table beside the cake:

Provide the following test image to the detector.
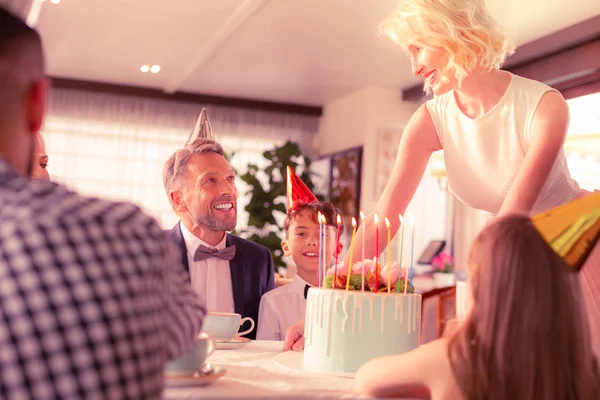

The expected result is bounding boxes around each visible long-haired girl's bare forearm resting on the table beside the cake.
[354,339,451,398]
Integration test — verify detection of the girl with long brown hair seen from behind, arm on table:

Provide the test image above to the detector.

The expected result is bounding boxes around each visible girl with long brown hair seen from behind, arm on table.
[355,215,600,400]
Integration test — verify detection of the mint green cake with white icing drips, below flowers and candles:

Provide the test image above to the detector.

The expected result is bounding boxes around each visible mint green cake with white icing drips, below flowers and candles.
[304,288,421,373]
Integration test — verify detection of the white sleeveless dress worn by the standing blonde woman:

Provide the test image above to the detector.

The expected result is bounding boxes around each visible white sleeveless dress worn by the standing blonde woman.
[426,74,600,354]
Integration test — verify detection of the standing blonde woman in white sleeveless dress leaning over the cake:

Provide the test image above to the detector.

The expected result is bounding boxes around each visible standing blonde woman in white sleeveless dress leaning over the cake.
[284,0,600,351]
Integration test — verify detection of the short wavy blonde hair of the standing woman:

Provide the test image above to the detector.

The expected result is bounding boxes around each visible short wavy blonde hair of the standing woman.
[380,0,515,82]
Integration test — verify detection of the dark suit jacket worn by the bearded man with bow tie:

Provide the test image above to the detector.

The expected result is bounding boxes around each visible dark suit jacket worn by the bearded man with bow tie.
[168,222,275,339]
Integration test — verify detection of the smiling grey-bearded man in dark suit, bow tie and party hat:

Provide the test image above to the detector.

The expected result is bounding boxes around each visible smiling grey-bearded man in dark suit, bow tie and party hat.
[163,110,274,339]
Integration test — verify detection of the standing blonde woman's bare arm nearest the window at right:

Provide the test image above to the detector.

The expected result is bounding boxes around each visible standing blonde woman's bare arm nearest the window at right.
[498,92,569,216]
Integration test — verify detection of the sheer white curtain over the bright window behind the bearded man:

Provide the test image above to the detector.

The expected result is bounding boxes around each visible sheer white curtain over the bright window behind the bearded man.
[42,89,319,228]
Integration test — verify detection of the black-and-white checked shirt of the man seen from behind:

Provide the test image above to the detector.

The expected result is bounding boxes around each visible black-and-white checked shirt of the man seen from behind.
[0,158,204,400]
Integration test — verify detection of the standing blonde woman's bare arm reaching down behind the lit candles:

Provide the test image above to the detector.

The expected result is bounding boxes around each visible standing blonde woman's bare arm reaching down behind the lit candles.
[344,104,442,263]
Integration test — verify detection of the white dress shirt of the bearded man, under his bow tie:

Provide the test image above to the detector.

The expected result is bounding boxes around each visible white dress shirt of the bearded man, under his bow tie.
[179,224,235,312]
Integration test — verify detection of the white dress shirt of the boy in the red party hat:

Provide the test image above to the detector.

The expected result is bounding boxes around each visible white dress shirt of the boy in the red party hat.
[256,275,312,340]
